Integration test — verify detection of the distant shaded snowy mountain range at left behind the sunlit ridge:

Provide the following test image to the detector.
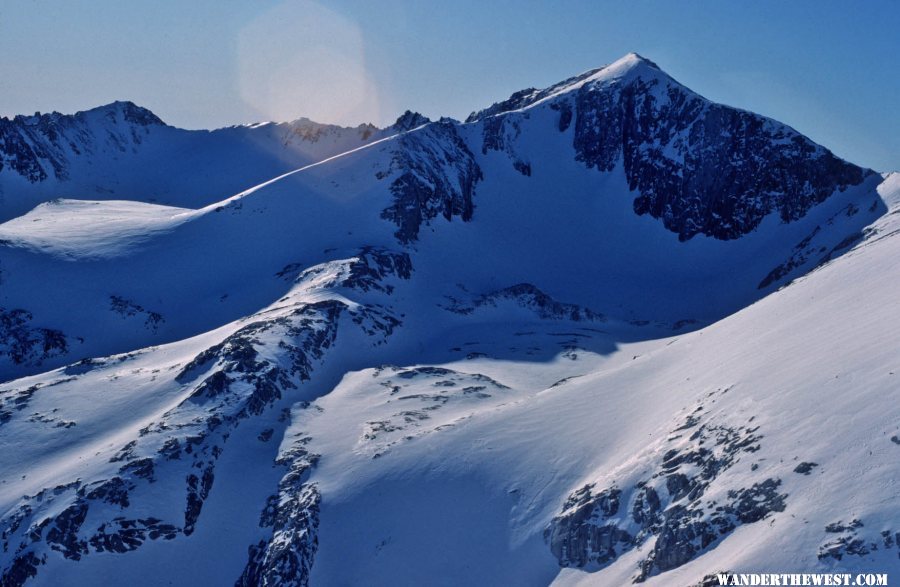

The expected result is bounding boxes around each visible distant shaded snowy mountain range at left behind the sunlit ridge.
[0,102,428,220]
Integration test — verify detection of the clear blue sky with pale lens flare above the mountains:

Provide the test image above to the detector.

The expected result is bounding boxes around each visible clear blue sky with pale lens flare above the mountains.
[0,0,900,170]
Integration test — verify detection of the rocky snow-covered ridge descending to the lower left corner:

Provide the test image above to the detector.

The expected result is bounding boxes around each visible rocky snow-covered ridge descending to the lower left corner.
[0,251,410,585]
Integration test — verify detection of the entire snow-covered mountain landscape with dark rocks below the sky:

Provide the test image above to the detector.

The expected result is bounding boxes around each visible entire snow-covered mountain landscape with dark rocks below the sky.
[0,54,900,586]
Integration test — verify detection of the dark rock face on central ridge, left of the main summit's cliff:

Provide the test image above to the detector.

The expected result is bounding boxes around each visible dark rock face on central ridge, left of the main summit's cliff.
[378,122,482,243]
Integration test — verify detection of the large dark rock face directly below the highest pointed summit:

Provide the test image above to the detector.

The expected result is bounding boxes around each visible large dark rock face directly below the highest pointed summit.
[560,77,871,240]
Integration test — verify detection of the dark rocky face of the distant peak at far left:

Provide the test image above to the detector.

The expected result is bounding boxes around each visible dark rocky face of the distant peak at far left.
[0,102,164,183]
